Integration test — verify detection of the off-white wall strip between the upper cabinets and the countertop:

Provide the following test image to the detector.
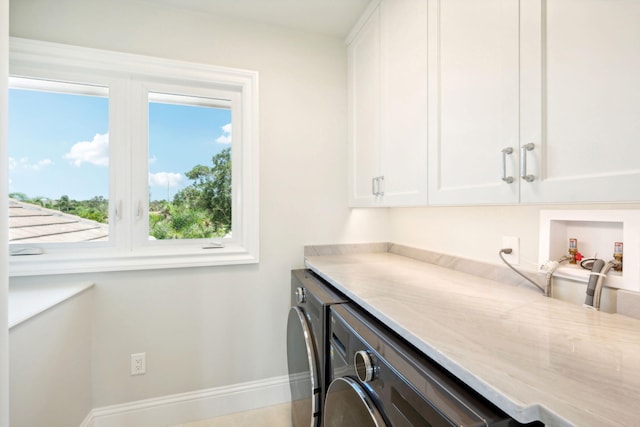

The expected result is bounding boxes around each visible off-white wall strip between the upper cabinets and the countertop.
[389,203,640,311]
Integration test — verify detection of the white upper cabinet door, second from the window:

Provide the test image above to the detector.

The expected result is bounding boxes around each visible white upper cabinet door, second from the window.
[380,0,427,206]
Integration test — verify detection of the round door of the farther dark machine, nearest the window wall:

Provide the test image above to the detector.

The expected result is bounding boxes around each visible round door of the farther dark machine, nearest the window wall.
[287,307,320,427]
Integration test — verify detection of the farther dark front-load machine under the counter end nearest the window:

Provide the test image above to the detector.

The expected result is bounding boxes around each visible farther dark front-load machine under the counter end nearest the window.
[287,270,346,427]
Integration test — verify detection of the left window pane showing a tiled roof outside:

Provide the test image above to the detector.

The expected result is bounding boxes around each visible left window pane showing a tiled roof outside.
[8,79,109,243]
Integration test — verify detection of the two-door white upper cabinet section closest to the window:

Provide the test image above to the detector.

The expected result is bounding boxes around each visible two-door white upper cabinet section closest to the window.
[348,0,427,206]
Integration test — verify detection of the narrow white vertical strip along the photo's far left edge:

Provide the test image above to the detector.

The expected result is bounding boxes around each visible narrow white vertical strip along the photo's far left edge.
[0,0,9,427]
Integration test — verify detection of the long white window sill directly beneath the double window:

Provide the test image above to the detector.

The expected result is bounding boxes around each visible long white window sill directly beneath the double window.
[9,245,258,277]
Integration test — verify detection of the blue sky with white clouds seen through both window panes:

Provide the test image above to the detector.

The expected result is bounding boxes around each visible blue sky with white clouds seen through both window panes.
[9,89,231,200]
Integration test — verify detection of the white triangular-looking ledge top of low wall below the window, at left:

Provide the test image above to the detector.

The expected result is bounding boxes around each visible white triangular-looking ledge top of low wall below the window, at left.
[9,282,93,330]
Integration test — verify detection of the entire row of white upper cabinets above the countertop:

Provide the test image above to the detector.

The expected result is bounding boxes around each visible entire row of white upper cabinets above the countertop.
[349,0,640,206]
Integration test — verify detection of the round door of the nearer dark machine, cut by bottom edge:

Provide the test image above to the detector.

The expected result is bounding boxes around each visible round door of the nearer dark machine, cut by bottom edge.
[324,377,387,427]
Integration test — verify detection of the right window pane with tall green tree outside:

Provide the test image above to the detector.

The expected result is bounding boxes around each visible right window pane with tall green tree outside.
[149,93,232,239]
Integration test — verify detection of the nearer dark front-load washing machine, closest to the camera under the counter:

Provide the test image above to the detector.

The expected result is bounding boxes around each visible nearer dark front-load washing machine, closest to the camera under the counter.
[323,304,542,427]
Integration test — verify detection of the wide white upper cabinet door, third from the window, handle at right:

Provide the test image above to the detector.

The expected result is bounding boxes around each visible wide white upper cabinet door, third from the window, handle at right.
[428,0,519,205]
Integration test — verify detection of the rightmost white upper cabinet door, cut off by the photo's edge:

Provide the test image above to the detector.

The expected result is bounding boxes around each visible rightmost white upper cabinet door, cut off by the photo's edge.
[521,0,640,202]
